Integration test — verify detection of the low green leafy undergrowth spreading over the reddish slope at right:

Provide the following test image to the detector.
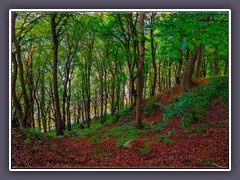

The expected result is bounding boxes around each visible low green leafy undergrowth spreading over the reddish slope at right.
[163,76,228,131]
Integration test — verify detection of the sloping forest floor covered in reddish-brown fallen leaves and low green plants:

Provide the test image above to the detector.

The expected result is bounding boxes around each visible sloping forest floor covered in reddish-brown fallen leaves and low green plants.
[11,78,229,169]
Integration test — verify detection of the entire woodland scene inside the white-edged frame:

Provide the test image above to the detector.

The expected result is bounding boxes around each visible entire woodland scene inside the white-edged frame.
[9,11,230,169]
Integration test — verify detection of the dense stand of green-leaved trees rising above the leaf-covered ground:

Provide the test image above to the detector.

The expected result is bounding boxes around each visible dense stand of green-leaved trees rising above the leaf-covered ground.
[11,11,229,135]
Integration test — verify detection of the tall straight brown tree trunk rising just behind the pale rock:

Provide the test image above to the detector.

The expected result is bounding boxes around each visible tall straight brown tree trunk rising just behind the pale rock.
[136,12,145,128]
